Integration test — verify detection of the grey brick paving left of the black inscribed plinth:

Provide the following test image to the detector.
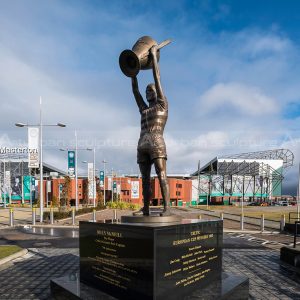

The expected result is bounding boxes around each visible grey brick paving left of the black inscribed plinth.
[0,248,78,300]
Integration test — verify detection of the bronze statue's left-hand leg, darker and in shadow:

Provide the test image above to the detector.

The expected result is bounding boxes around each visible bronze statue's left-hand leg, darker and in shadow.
[139,162,152,216]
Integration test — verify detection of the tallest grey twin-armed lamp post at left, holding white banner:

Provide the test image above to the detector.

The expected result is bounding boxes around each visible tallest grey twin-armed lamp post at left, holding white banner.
[15,98,66,223]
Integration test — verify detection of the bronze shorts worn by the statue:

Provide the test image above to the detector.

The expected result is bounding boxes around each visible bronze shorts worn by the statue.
[137,133,167,164]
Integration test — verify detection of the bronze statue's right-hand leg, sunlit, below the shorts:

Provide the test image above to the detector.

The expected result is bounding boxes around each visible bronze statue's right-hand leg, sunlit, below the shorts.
[154,157,170,215]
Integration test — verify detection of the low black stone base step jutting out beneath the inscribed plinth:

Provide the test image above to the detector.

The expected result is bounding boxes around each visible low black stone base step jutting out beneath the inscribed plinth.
[50,273,249,300]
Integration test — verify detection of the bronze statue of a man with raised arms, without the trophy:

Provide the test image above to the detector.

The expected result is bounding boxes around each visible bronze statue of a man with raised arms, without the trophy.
[131,45,170,216]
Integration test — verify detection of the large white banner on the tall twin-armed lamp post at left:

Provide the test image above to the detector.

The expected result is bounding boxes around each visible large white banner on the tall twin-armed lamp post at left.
[28,127,40,169]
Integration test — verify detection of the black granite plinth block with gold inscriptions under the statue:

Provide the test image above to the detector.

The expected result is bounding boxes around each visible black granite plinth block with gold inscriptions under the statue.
[79,220,223,300]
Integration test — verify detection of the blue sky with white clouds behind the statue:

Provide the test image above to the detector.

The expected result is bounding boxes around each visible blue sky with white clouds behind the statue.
[0,0,300,191]
